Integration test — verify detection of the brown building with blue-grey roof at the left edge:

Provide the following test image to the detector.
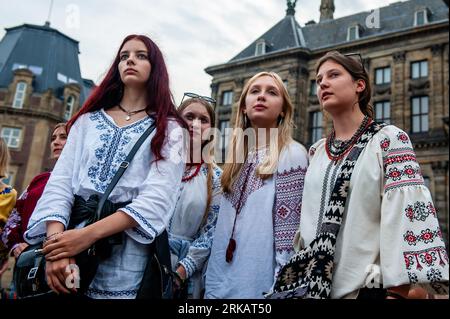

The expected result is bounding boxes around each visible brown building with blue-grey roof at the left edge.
[0,23,94,192]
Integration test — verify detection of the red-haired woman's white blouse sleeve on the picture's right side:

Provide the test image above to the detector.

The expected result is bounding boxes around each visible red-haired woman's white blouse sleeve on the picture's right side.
[121,122,185,244]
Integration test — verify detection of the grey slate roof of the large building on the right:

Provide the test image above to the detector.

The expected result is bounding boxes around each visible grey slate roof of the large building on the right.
[219,0,448,63]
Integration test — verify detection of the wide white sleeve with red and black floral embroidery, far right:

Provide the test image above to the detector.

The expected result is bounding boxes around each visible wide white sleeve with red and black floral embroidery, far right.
[380,126,449,287]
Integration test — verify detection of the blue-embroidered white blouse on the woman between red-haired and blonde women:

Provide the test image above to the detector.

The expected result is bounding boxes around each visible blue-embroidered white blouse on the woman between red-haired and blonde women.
[169,164,222,298]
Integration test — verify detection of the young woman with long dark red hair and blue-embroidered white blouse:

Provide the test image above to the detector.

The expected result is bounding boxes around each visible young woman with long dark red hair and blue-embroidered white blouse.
[25,35,185,298]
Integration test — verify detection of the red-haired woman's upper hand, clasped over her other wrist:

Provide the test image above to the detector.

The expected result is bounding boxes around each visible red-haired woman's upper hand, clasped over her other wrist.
[43,227,95,261]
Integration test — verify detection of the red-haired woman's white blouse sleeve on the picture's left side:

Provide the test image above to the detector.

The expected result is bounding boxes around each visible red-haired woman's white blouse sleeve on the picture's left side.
[24,116,84,244]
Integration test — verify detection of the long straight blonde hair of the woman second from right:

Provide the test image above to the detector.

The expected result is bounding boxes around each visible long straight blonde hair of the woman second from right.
[221,72,294,193]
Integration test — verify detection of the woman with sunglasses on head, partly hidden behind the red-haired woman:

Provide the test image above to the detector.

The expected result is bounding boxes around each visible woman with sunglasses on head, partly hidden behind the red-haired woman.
[169,93,222,299]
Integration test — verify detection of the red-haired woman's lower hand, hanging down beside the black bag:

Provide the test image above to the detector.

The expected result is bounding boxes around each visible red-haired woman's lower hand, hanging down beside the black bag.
[45,258,80,295]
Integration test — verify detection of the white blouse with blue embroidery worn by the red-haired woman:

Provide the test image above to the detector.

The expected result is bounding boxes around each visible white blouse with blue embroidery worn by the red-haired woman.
[24,109,184,298]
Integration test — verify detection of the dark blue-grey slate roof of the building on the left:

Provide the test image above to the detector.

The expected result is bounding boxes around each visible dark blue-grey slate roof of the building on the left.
[0,24,91,101]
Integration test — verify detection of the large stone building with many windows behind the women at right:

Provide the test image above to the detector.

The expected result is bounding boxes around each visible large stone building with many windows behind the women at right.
[205,0,449,247]
